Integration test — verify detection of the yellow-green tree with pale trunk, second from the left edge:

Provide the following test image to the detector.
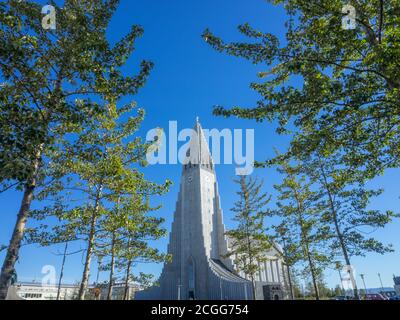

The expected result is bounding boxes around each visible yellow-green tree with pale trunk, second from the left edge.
[32,98,170,299]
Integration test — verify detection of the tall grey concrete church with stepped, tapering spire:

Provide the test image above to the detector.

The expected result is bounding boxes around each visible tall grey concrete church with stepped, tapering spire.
[135,120,288,300]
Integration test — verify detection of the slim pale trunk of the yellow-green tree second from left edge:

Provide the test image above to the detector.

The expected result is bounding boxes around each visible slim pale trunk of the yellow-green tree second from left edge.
[78,186,103,300]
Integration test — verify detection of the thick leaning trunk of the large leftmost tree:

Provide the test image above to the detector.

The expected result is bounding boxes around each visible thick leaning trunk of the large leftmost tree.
[0,146,43,300]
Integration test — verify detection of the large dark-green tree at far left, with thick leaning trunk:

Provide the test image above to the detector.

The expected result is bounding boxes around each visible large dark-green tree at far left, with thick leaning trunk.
[0,0,152,299]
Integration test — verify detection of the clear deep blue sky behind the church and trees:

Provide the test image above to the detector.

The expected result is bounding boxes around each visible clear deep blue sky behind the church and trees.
[0,0,400,287]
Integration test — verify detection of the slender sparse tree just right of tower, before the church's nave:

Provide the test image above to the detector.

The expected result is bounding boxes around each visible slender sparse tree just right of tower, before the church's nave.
[226,176,271,299]
